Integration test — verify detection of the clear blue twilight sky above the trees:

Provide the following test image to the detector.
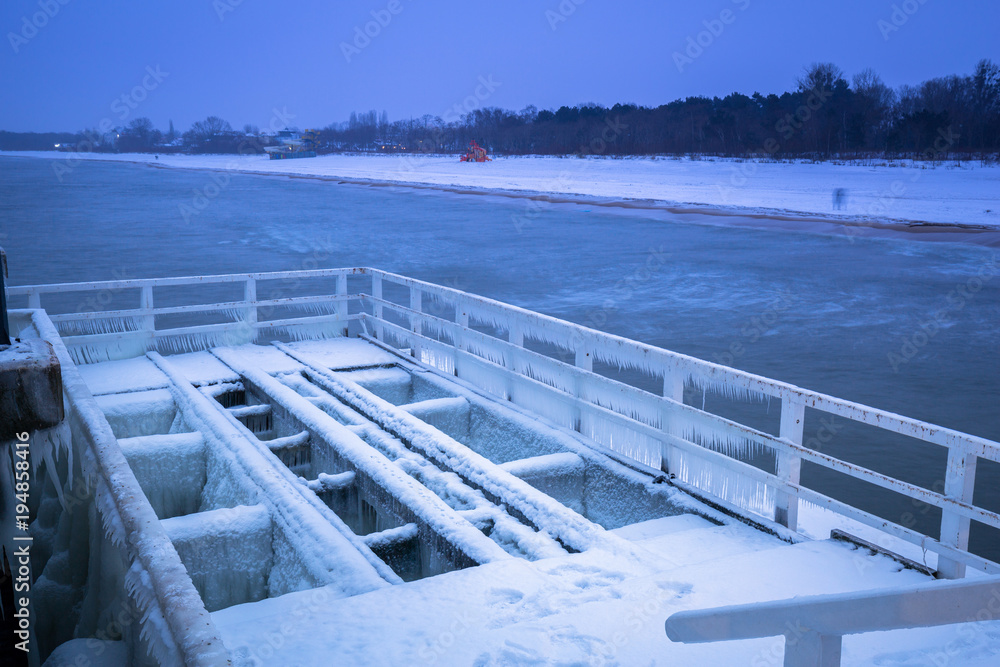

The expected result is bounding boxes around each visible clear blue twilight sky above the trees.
[0,0,1000,131]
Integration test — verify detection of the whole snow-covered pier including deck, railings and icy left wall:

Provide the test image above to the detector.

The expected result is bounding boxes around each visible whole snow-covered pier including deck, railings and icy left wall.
[4,268,1000,665]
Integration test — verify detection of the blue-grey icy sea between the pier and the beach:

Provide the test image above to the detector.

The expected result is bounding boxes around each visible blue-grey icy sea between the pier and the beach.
[0,157,1000,559]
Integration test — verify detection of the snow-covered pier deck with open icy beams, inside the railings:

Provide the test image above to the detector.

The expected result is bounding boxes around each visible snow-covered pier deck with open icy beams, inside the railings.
[58,339,988,665]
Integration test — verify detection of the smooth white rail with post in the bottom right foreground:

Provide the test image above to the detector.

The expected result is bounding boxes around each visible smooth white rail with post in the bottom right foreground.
[665,577,1000,667]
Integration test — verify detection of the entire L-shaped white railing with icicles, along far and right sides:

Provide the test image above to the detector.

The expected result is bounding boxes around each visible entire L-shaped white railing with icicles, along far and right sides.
[9,268,1000,578]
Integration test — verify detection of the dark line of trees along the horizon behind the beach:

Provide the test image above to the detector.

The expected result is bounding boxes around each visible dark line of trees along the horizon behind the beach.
[0,60,1000,159]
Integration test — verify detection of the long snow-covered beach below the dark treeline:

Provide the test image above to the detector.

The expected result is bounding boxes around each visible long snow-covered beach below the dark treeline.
[7,151,1000,236]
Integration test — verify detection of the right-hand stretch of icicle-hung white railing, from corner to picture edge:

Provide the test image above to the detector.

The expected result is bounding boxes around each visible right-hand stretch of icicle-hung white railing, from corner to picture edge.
[363,270,1000,578]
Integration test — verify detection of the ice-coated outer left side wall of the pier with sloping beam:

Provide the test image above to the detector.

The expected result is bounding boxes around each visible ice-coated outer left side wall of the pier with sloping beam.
[12,310,230,667]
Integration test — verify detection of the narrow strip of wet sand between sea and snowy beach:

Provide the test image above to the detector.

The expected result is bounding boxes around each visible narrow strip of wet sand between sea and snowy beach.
[7,151,1000,247]
